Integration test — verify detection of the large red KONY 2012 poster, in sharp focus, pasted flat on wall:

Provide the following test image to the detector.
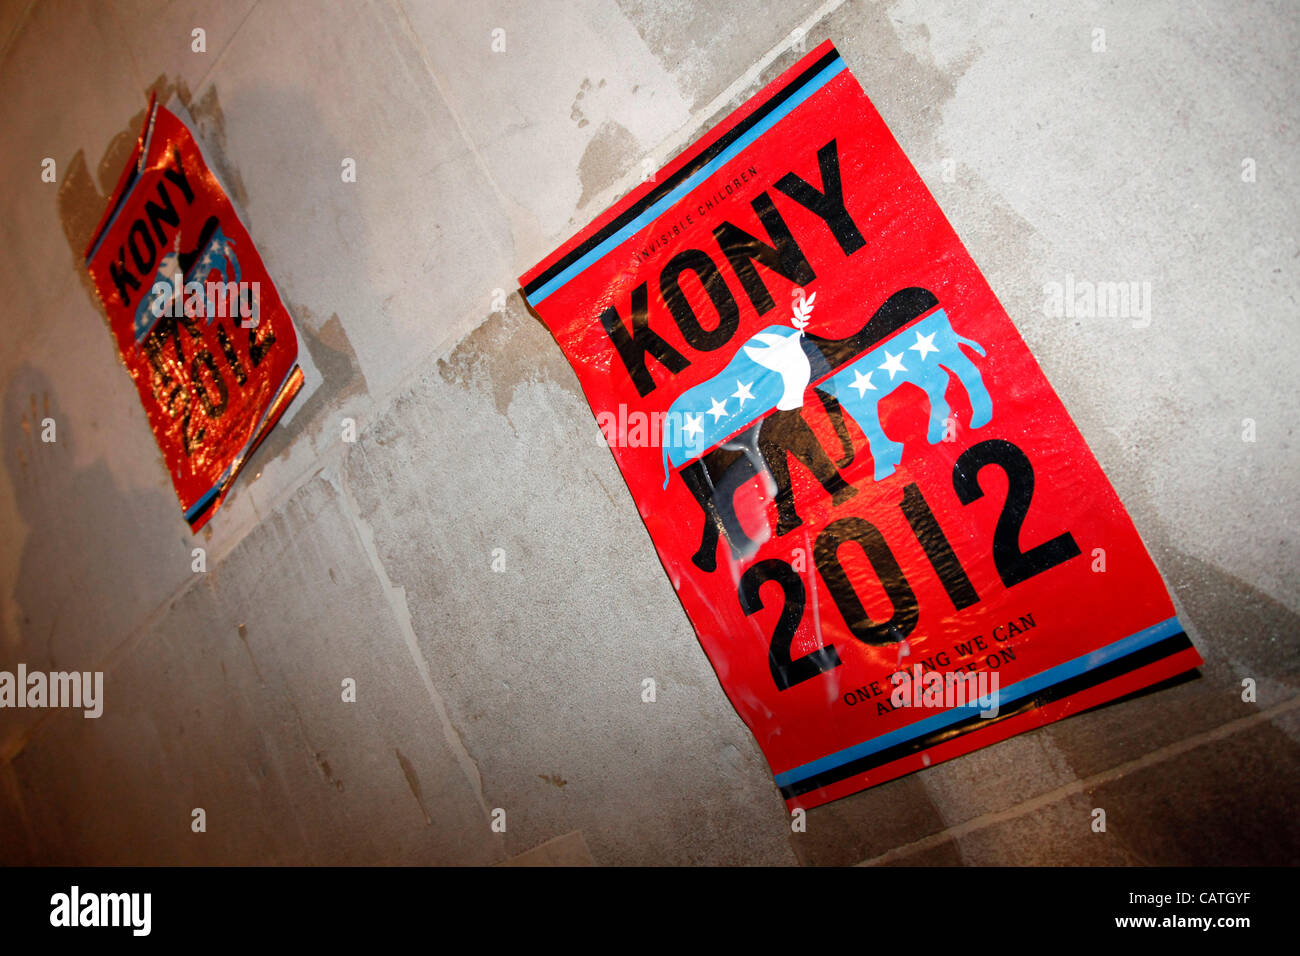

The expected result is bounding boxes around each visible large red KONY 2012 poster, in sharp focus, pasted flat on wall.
[520,43,1200,808]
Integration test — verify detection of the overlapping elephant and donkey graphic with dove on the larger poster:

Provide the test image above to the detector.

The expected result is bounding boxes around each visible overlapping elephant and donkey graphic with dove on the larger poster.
[663,287,993,571]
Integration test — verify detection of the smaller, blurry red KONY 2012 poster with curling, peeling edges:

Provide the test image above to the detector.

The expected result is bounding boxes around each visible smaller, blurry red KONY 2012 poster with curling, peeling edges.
[86,103,303,531]
